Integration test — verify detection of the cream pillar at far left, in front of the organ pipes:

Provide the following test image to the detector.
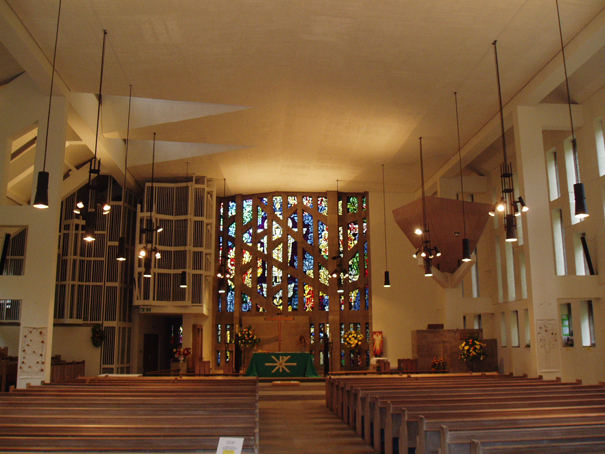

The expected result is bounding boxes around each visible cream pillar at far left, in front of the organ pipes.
[0,79,68,388]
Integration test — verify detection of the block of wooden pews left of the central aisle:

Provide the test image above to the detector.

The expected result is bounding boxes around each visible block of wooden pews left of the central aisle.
[0,377,259,454]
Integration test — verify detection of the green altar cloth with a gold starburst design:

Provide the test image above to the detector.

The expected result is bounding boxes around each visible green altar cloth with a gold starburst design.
[246,352,319,378]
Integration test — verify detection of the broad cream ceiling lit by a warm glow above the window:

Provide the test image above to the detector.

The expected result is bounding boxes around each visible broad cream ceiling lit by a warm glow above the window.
[0,0,605,194]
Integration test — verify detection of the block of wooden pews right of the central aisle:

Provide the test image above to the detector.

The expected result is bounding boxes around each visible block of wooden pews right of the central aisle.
[326,374,605,454]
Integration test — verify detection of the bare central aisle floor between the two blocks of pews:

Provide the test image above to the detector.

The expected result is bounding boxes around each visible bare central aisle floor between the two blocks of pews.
[259,383,374,454]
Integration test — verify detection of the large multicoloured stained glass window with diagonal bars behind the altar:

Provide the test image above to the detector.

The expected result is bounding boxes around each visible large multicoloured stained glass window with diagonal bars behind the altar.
[213,192,371,369]
